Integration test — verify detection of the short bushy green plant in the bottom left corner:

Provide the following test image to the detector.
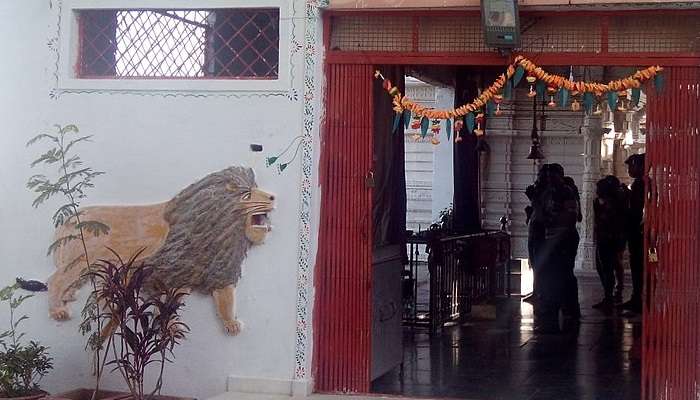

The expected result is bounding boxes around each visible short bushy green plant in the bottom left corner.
[0,284,53,400]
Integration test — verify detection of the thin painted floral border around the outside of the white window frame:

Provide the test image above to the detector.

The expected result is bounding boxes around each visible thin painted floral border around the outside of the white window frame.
[47,0,302,102]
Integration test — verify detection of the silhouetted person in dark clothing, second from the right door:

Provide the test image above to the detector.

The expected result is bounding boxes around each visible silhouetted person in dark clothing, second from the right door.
[593,175,627,311]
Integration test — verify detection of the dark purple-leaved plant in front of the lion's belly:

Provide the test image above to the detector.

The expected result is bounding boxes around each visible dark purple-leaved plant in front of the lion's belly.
[90,252,189,400]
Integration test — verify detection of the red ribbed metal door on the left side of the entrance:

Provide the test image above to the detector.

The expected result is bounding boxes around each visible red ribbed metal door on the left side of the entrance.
[314,65,373,393]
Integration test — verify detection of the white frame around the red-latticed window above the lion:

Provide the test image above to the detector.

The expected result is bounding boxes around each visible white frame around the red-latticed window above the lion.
[58,0,294,92]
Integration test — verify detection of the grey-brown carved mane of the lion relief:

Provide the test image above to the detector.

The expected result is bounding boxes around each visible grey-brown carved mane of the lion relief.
[144,167,256,294]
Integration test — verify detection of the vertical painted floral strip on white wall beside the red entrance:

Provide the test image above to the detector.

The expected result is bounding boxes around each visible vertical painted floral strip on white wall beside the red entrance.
[294,0,328,381]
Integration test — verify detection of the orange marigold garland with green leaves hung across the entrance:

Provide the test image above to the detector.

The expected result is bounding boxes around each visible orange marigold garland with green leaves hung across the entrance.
[374,56,663,120]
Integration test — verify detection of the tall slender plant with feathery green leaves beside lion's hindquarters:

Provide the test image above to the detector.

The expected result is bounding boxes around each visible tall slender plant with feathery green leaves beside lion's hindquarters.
[27,125,109,397]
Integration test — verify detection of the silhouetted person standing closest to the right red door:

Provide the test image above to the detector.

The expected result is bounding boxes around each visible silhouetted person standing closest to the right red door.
[621,154,645,313]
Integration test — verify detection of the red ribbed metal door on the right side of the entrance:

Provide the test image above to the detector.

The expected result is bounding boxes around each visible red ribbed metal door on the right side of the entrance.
[642,67,700,400]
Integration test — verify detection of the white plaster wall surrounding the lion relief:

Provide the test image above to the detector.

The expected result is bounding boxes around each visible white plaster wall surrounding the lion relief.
[0,0,316,398]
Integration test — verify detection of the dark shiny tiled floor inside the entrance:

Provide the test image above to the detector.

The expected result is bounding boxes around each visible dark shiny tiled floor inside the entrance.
[372,276,641,400]
